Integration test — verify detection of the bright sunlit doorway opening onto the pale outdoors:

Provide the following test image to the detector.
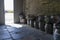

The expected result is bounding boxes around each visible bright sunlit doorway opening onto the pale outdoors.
[4,0,14,25]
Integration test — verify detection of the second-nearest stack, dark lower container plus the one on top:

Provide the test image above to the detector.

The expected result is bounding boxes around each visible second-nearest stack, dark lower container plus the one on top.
[45,16,53,34]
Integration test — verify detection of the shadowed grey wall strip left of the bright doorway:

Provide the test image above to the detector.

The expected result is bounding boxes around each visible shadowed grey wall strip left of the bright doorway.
[0,0,5,25]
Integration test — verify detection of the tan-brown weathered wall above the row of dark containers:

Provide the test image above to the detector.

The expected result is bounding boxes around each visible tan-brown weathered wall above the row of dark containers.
[24,0,60,15]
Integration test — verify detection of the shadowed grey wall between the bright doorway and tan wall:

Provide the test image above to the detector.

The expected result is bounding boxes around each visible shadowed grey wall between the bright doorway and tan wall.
[14,0,23,23]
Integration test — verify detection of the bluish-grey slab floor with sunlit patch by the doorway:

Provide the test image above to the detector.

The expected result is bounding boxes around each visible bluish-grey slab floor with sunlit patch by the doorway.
[0,24,53,40]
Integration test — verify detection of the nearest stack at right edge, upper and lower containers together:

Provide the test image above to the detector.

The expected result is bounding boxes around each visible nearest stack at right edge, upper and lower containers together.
[53,16,60,40]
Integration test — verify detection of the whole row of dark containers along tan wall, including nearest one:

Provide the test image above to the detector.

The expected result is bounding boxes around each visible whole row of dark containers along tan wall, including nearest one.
[27,15,60,40]
